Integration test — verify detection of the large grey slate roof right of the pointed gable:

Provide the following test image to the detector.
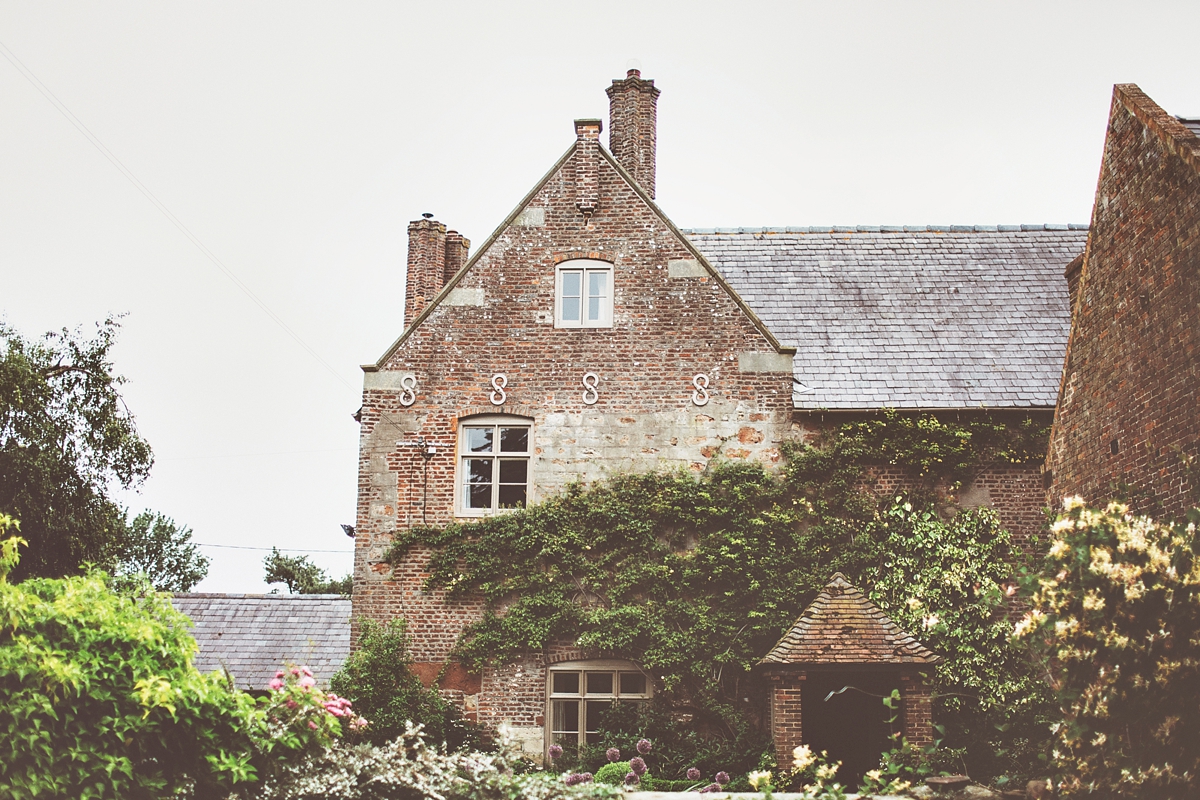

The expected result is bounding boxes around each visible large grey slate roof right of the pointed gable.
[685,225,1087,410]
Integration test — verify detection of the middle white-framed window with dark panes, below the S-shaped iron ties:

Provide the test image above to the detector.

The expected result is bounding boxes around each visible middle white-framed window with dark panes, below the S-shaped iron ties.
[456,415,533,517]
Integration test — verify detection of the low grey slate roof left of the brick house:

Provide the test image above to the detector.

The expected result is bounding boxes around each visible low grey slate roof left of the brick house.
[170,593,350,690]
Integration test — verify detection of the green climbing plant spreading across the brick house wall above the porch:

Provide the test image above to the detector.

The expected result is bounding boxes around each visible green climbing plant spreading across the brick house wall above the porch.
[385,413,1048,771]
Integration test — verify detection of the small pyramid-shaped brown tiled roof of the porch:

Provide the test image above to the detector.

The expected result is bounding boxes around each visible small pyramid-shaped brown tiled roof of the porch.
[758,572,941,666]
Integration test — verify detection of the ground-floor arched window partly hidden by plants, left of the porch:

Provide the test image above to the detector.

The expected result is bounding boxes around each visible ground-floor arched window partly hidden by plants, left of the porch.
[546,658,652,747]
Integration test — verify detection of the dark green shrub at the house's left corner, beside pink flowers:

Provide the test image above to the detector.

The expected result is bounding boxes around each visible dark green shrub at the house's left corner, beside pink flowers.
[330,619,480,750]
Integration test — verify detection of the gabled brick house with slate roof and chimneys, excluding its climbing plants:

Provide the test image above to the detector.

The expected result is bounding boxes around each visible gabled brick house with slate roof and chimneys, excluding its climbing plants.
[353,70,1087,753]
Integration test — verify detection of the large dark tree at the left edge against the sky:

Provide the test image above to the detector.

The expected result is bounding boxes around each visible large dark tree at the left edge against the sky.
[0,319,154,581]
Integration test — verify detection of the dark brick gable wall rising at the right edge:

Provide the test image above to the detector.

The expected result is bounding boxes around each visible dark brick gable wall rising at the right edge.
[1046,85,1200,516]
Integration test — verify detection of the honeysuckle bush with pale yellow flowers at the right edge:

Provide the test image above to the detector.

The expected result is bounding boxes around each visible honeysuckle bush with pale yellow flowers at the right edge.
[1016,498,1200,798]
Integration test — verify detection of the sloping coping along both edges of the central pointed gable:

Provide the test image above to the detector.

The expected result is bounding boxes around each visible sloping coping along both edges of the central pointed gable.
[361,140,796,372]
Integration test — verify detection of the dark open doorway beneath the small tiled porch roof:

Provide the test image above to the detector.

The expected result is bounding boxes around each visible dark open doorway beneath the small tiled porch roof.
[800,669,900,789]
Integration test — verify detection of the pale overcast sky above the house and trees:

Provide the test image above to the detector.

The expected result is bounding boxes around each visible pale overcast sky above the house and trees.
[0,0,1200,591]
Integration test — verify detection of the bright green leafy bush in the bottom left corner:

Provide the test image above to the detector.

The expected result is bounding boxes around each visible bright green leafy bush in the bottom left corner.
[0,518,254,799]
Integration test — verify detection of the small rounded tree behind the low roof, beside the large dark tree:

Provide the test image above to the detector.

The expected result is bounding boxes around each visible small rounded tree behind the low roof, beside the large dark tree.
[115,511,209,591]
